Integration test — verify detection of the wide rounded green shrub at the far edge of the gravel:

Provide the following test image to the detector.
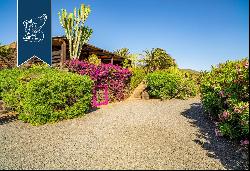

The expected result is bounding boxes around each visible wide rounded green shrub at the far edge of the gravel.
[147,67,198,99]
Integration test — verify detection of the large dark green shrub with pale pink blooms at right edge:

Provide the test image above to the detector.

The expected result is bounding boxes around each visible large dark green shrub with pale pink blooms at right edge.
[201,59,249,144]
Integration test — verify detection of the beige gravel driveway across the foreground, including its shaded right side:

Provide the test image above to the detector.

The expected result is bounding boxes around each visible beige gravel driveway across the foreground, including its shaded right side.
[0,98,246,169]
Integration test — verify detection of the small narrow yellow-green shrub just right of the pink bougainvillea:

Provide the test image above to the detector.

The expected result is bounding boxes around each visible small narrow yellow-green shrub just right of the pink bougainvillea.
[130,68,146,91]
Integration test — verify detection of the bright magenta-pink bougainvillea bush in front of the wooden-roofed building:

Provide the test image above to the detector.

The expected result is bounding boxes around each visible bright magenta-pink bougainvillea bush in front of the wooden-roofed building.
[66,60,132,106]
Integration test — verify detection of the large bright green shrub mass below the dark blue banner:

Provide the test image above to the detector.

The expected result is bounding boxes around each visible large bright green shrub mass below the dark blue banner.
[0,67,93,125]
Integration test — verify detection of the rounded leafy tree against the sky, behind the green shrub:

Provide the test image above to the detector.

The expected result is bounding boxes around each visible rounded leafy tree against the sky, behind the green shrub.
[142,48,177,72]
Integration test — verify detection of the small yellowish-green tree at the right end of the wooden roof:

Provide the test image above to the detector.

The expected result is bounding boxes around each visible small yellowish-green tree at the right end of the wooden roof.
[114,48,138,68]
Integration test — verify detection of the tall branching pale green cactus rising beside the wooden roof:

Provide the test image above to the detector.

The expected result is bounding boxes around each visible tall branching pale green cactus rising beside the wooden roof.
[58,4,93,59]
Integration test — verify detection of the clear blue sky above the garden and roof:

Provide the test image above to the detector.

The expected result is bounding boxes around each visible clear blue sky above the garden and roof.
[0,0,249,70]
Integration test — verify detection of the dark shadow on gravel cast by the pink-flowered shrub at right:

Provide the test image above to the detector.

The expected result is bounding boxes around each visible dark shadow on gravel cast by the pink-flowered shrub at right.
[182,103,248,170]
